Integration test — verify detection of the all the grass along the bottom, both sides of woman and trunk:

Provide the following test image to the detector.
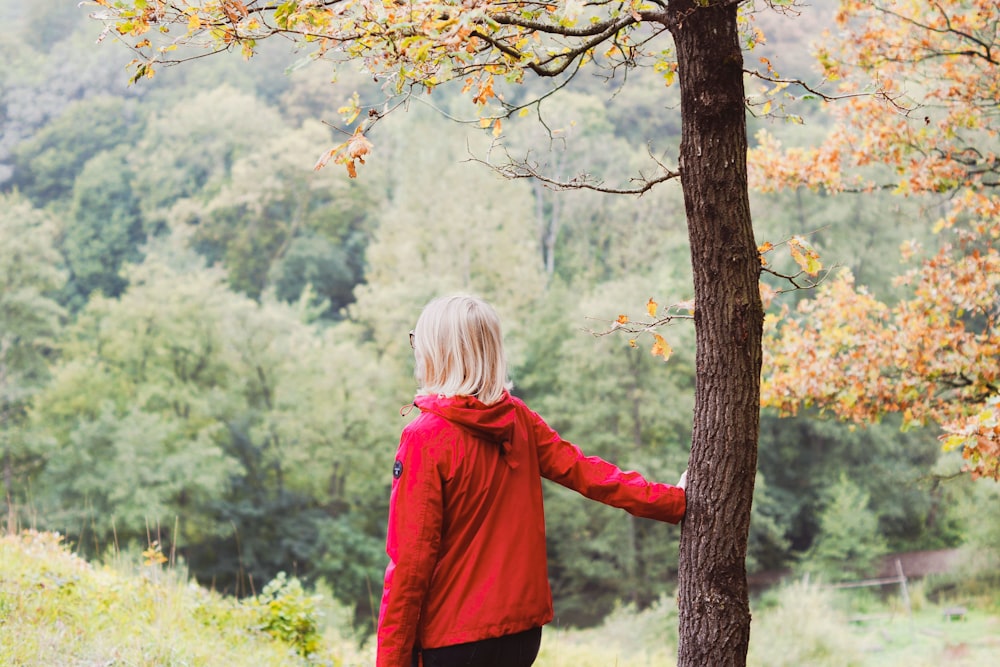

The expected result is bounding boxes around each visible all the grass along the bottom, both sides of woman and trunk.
[0,532,1000,667]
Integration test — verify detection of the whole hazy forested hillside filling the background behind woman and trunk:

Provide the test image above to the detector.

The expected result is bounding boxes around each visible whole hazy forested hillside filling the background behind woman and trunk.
[0,0,1000,664]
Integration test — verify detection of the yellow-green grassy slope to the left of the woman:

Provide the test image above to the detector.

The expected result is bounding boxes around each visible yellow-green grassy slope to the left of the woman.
[0,532,374,667]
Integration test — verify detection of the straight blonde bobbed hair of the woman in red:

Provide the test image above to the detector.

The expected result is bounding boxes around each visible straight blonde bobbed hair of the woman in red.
[413,295,511,405]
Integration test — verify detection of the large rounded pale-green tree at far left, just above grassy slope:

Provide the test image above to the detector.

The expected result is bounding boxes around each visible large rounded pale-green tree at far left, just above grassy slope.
[34,248,248,548]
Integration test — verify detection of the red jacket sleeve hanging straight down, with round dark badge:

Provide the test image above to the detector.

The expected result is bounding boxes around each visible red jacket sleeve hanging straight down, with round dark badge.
[376,431,442,667]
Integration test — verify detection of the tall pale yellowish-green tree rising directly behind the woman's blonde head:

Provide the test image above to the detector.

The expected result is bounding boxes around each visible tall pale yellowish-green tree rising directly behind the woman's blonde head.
[350,112,544,352]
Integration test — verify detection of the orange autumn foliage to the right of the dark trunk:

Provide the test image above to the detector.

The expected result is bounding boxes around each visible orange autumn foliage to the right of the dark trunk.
[751,0,1000,477]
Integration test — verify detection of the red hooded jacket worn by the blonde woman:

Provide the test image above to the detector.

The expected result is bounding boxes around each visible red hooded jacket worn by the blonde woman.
[377,395,685,667]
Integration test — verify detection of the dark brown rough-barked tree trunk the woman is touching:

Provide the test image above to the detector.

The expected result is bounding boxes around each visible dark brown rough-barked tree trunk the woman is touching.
[669,0,763,667]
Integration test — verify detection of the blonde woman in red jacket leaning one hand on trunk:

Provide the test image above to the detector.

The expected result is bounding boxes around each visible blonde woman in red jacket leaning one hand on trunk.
[377,296,685,667]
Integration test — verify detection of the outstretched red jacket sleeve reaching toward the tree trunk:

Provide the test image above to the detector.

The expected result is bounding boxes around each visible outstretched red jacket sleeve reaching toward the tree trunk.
[531,413,686,523]
